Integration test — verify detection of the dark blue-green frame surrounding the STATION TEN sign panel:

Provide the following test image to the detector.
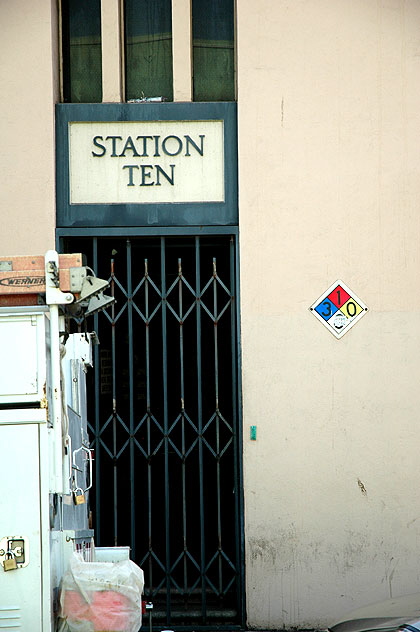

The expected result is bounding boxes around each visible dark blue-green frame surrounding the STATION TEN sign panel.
[56,102,238,228]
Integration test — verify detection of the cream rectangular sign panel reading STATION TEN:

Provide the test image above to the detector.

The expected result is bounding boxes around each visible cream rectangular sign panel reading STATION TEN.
[69,121,225,204]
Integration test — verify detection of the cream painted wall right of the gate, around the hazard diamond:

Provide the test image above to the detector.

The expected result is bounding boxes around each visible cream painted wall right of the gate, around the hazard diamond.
[237,0,420,629]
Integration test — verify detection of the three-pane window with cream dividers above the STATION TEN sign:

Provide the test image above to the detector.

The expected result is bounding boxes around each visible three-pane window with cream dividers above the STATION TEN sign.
[60,0,235,103]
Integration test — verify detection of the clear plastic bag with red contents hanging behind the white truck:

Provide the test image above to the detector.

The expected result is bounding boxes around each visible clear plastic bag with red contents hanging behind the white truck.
[59,553,144,632]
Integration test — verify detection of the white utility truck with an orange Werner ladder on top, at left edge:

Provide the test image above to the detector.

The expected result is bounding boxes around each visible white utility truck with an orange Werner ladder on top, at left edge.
[0,251,143,632]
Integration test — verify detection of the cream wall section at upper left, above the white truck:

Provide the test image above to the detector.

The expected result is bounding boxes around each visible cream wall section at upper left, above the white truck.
[0,0,58,256]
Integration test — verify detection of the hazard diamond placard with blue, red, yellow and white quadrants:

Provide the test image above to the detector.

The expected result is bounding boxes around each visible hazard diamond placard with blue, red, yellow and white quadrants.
[309,280,368,338]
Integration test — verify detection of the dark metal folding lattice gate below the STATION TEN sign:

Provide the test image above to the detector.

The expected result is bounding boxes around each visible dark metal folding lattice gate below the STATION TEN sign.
[64,235,243,629]
